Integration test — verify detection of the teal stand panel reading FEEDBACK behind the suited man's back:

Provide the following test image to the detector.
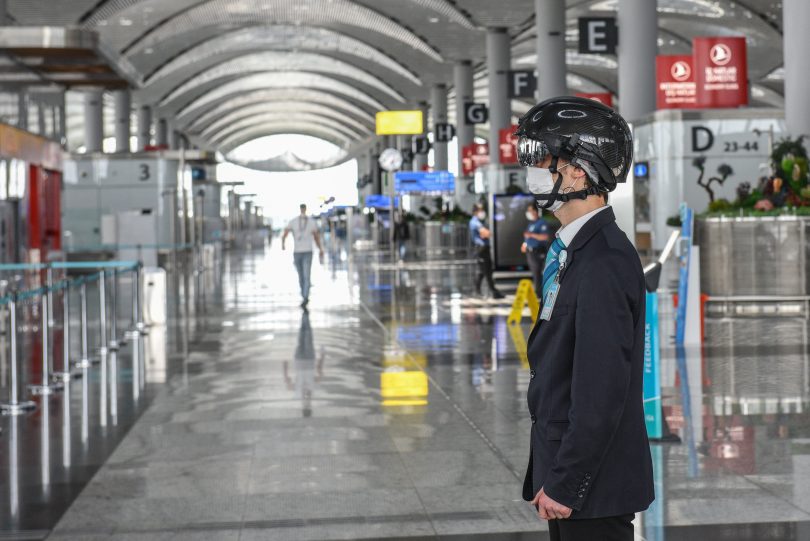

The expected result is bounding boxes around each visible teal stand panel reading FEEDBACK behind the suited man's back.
[644,291,664,439]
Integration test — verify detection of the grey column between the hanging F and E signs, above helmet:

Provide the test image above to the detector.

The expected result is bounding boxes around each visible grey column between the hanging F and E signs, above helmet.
[535,0,568,101]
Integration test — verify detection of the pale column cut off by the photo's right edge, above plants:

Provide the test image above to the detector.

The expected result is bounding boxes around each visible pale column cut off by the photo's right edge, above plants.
[782,0,810,137]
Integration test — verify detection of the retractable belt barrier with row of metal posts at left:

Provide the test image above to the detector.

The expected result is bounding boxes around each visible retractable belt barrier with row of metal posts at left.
[0,261,146,415]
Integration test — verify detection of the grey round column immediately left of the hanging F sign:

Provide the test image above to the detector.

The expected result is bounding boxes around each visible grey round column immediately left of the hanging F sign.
[487,28,512,162]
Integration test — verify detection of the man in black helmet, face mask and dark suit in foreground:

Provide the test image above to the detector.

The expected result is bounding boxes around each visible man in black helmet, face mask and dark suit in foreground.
[517,97,654,541]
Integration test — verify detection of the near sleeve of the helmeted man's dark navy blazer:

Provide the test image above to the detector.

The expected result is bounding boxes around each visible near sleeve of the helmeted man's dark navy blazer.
[543,252,640,511]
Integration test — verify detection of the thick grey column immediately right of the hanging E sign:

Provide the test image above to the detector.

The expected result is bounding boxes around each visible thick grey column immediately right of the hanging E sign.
[617,0,658,122]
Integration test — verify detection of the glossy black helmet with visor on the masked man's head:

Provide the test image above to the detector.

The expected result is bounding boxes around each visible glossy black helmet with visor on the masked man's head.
[515,96,633,195]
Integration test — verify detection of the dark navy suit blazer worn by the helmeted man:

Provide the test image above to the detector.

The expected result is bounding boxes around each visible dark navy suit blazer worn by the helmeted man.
[523,208,655,519]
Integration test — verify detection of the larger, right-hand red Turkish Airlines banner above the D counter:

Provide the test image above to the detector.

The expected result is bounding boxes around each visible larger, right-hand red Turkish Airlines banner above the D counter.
[692,37,748,108]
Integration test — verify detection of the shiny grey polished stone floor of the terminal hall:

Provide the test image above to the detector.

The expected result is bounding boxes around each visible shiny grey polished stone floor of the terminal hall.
[0,243,810,541]
